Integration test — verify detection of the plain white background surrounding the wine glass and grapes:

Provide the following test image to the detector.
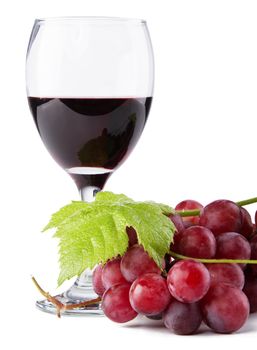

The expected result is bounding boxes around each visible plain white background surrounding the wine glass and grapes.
[0,0,257,349]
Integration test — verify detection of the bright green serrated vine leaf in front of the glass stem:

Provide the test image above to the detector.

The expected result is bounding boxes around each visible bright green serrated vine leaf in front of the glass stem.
[43,192,175,285]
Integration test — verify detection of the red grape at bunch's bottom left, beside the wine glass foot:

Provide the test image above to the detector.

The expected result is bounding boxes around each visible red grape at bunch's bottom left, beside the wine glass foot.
[102,282,137,323]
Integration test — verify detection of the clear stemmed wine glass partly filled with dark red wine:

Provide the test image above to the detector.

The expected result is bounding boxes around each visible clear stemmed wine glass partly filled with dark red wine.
[26,17,154,314]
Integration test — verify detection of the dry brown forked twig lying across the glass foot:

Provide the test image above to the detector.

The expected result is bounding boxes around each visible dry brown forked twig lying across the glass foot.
[32,277,102,318]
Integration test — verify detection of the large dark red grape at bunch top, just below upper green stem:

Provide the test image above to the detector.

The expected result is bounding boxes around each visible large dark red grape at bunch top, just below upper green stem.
[199,199,241,236]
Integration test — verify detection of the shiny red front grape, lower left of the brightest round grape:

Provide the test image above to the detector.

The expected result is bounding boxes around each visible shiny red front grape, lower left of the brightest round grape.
[129,273,171,316]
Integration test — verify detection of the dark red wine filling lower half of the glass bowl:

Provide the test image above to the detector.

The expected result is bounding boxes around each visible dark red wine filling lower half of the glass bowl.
[28,97,152,188]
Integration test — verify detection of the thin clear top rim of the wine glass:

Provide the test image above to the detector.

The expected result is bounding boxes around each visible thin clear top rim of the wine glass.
[35,16,146,24]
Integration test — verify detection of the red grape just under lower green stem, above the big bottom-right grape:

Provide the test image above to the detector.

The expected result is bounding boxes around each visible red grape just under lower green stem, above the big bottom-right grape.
[206,264,245,289]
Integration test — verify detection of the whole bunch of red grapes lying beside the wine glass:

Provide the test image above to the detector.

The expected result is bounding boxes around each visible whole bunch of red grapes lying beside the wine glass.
[93,200,257,335]
